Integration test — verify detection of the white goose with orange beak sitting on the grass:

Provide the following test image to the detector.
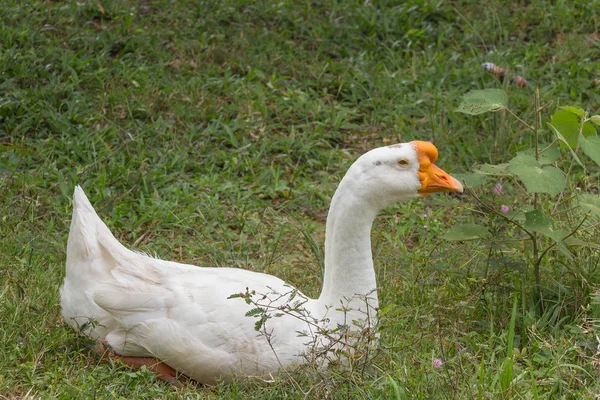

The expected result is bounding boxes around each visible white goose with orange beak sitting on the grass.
[61,141,462,384]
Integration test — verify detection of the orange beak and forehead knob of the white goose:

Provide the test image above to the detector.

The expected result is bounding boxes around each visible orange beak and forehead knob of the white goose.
[412,140,463,195]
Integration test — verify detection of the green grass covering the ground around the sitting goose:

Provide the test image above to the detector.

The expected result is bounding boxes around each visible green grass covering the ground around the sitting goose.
[0,0,600,399]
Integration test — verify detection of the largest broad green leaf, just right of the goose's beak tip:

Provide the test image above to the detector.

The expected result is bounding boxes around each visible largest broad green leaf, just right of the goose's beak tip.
[508,154,566,196]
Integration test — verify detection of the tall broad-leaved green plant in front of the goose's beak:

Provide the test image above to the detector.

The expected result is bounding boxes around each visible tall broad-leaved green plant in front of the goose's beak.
[450,89,600,314]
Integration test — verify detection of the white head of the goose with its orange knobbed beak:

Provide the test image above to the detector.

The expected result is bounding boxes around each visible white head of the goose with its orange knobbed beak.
[348,141,463,209]
